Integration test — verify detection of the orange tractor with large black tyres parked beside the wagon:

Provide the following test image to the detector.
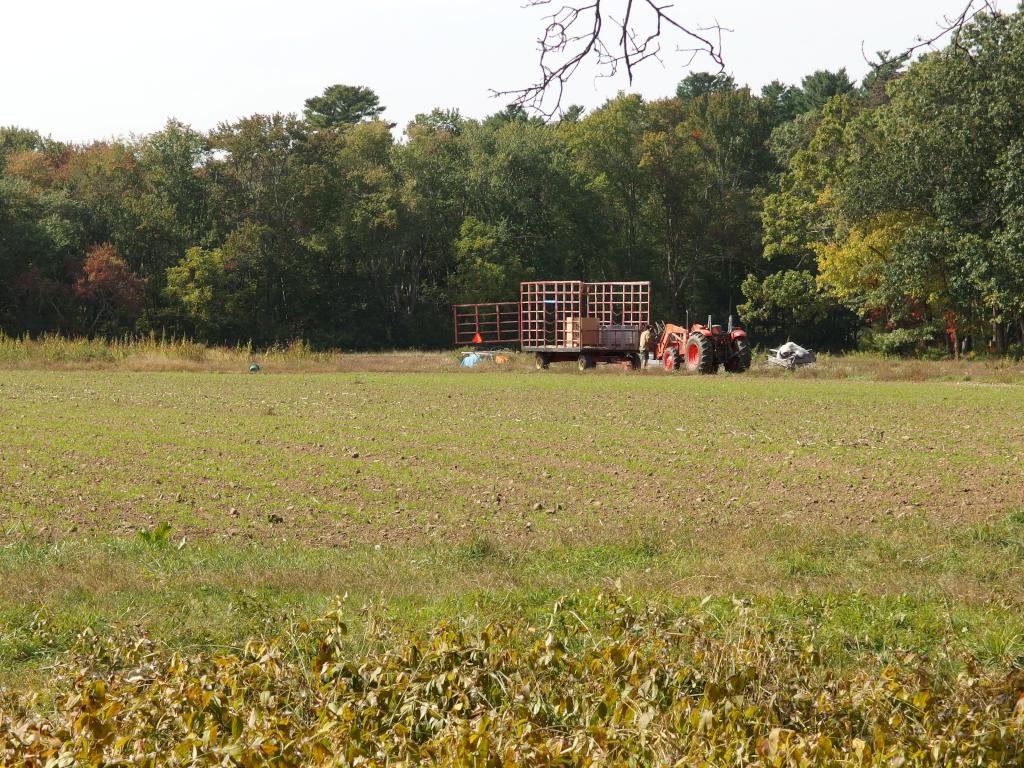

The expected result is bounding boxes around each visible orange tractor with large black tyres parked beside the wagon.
[654,317,752,374]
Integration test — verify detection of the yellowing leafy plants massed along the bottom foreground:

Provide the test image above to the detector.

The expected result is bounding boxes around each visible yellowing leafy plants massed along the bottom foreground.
[0,594,1024,766]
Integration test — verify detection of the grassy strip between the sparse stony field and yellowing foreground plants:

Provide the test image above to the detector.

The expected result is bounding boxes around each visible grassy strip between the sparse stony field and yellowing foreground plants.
[0,532,1024,681]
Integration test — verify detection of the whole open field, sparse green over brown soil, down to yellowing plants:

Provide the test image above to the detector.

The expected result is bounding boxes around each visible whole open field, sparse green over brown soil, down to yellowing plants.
[0,371,1024,682]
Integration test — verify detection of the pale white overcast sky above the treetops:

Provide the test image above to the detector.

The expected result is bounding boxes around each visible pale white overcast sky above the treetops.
[0,0,991,142]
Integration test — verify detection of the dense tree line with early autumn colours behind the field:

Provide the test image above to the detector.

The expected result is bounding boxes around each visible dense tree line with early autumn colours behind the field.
[0,11,1024,353]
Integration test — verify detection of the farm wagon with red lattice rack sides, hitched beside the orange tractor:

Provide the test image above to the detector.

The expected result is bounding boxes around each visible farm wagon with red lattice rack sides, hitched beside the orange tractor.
[453,281,650,371]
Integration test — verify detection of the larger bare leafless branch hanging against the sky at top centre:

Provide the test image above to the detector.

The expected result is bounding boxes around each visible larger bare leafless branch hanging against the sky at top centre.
[492,0,725,119]
